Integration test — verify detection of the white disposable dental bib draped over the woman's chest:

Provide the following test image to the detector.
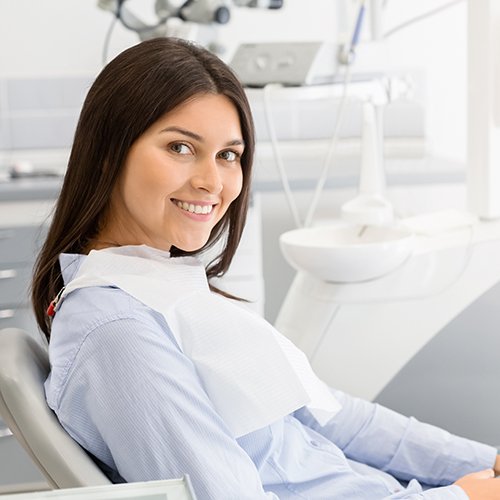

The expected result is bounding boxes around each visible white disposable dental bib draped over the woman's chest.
[58,246,341,437]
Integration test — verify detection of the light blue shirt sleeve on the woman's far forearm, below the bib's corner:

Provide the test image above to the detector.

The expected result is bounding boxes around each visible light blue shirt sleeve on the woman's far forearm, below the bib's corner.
[295,391,497,486]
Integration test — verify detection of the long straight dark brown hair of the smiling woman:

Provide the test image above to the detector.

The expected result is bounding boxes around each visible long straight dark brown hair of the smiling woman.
[32,38,255,339]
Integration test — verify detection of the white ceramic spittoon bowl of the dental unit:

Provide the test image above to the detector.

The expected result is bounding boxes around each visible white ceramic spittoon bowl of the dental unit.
[280,226,414,283]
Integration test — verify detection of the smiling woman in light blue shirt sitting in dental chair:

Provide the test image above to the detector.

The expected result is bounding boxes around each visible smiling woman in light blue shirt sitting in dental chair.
[33,39,500,500]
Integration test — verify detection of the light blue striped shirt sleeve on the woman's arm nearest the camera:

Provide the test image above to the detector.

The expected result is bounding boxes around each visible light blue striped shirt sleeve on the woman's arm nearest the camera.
[54,312,277,500]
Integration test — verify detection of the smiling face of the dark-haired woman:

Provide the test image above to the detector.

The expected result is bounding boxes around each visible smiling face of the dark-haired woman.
[98,94,245,251]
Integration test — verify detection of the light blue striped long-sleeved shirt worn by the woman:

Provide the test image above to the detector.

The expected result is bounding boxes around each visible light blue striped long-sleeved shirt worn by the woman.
[45,255,496,500]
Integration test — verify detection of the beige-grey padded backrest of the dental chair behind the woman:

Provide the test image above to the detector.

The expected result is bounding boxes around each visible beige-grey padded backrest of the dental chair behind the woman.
[0,328,111,488]
